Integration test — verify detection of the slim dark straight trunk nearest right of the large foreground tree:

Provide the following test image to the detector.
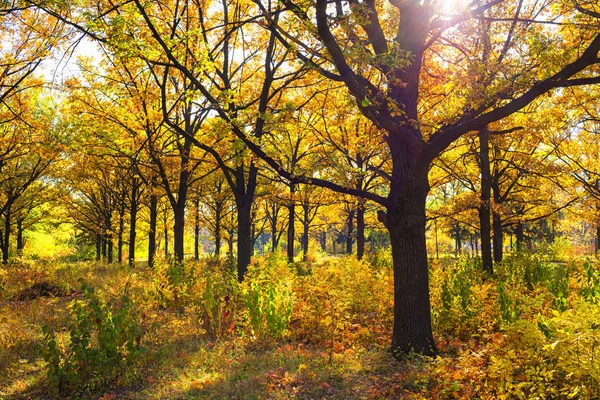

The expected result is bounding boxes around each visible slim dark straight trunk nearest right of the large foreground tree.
[479,128,494,274]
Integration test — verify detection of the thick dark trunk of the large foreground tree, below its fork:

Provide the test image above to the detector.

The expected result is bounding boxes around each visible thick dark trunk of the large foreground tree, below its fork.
[380,168,436,357]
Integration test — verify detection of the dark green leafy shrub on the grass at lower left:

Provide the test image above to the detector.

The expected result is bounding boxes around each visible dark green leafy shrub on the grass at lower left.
[40,282,145,394]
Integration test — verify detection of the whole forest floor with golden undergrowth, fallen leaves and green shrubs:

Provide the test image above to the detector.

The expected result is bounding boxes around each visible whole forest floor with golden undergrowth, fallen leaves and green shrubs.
[0,252,600,399]
